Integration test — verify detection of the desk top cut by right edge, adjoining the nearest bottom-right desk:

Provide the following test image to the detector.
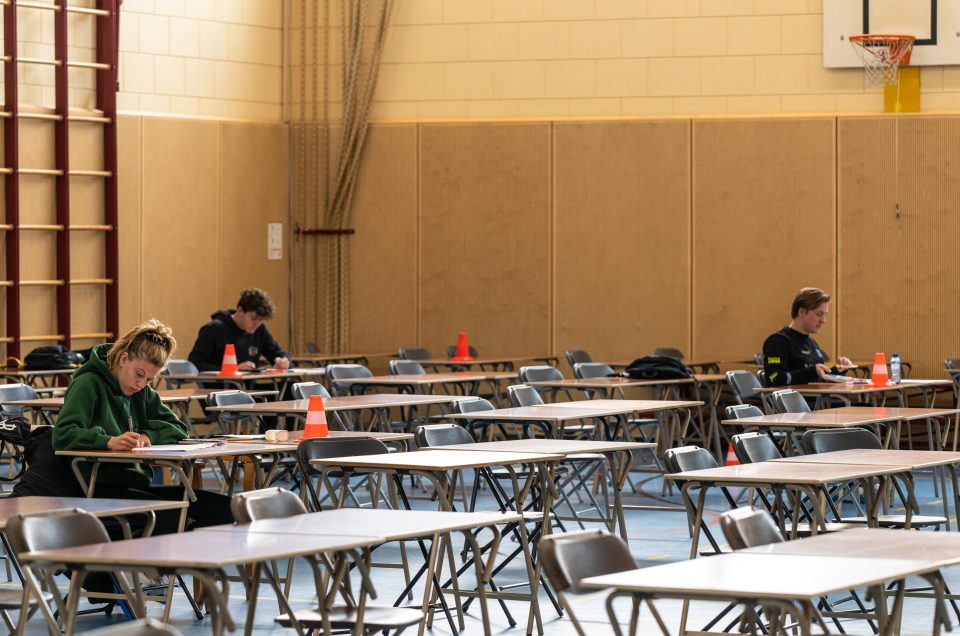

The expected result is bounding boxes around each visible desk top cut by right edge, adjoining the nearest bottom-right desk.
[741,528,960,568]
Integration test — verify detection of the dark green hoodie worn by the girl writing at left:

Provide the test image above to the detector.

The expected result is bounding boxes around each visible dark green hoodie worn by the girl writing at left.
[53,343,187,488]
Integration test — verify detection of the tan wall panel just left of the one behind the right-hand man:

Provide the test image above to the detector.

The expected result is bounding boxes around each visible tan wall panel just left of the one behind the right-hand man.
[554,121,690,360]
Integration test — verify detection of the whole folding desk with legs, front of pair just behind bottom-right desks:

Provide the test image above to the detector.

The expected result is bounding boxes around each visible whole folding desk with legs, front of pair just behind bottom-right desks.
[665,461,911,559]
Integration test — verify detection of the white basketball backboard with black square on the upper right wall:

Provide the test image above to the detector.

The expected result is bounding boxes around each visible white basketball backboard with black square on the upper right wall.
[823,0,960,68]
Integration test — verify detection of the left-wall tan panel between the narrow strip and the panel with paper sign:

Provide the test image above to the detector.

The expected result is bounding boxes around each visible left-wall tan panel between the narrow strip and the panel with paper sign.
[141,117,221,357]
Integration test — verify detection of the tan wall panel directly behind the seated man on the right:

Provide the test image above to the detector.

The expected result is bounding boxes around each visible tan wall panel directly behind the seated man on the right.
[693,118,838,360]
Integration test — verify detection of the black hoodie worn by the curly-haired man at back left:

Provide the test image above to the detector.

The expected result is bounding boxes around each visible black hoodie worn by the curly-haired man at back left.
[188,309,287,371]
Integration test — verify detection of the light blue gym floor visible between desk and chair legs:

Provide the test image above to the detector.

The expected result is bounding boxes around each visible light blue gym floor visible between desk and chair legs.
[16,474,960,636]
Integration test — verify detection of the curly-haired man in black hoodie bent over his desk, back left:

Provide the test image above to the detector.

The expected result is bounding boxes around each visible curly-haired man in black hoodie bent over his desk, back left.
[189,288,290,371]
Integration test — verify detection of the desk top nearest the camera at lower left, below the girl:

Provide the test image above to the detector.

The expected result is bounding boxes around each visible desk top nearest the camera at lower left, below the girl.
[20,526,385,570]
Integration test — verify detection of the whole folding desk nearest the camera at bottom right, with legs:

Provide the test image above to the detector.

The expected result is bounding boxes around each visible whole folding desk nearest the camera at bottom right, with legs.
[580,552,936,635]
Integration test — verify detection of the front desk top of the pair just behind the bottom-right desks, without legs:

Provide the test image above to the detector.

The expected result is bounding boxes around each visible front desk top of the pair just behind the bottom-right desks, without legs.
[665,461,910,485]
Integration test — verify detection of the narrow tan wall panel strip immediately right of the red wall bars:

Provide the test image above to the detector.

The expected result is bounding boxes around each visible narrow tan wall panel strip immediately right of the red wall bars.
[117,116,142,332]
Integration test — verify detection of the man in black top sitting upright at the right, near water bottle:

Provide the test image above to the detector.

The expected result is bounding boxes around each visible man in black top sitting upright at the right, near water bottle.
[763,287,854,386]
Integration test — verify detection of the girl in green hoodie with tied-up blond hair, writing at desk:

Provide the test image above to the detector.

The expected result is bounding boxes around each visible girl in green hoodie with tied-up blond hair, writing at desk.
[53,320,233,534]
